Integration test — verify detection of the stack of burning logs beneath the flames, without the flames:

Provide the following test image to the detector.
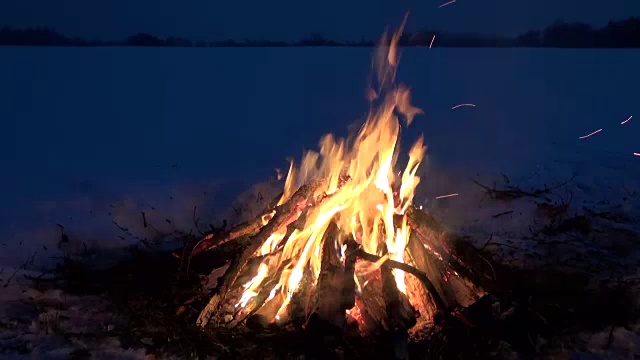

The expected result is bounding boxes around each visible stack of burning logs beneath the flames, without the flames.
[192,181,483,335]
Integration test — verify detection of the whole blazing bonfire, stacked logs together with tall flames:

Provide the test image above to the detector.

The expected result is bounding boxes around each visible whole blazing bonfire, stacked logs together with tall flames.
[192,21,483,346]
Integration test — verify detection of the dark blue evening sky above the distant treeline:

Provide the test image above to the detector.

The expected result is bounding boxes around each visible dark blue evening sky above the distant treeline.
[0,0,640,40]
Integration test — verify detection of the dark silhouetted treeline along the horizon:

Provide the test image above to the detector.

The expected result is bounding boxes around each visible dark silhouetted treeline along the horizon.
[0,17,640,48]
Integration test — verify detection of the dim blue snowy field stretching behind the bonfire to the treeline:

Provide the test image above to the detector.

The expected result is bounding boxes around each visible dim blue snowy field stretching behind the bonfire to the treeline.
[0,47,640,358]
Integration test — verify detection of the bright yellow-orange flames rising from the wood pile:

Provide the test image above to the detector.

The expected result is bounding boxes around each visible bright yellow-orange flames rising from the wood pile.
[236,22,425,319]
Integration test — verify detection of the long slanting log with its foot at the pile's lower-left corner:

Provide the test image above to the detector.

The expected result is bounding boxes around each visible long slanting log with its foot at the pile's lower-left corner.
[196,179,326,327]
